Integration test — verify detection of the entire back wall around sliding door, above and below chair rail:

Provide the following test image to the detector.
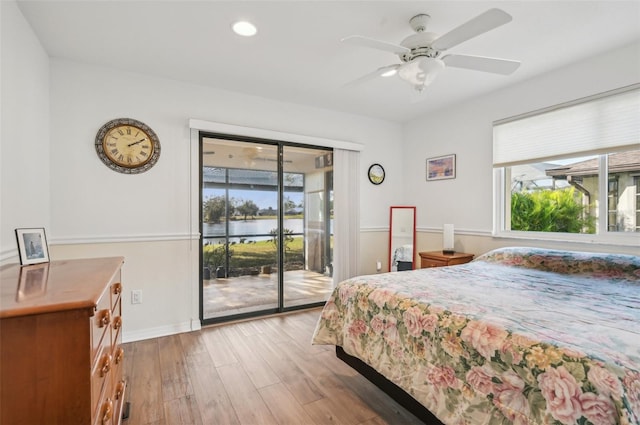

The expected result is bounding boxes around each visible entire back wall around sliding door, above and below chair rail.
[45,59,402,339]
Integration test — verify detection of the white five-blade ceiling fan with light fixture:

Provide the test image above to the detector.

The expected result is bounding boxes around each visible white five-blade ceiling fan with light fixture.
[341,9,520,92]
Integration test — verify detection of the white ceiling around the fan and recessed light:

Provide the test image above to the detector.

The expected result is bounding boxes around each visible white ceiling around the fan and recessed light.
[18,0,640,122]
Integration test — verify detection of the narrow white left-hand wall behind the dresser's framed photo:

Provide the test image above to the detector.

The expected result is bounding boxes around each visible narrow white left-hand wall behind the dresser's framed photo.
[0,1,50,261]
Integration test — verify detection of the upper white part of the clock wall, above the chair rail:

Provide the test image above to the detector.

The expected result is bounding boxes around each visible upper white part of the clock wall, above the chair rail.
[51,59,402,242]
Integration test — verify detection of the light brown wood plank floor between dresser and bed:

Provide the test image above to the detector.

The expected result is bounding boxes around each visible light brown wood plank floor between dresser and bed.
[123,309,428,425]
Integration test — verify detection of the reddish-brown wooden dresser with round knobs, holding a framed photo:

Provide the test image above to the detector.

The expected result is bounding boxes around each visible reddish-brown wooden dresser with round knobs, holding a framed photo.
[0,257,126,425]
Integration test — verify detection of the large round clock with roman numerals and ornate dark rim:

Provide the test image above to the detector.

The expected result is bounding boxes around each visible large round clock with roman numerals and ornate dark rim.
[95,118,160,174]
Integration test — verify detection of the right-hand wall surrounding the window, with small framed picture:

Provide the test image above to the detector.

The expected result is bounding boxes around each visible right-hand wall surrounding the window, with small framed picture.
[404,44,640,254]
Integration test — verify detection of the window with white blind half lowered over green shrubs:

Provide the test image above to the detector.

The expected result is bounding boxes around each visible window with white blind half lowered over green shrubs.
[493,84,640,246]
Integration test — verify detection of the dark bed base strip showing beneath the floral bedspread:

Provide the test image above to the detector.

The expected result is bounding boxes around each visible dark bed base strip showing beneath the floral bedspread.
[336,345,443,425]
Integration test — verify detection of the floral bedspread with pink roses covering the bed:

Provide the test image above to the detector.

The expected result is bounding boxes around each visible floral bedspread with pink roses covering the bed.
[312,248,640,425]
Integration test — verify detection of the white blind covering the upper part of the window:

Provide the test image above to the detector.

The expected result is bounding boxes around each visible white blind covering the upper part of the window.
[493,84,640,167]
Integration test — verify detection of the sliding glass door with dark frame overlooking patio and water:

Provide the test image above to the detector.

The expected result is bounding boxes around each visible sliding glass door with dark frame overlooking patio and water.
[201,135,333,323]
